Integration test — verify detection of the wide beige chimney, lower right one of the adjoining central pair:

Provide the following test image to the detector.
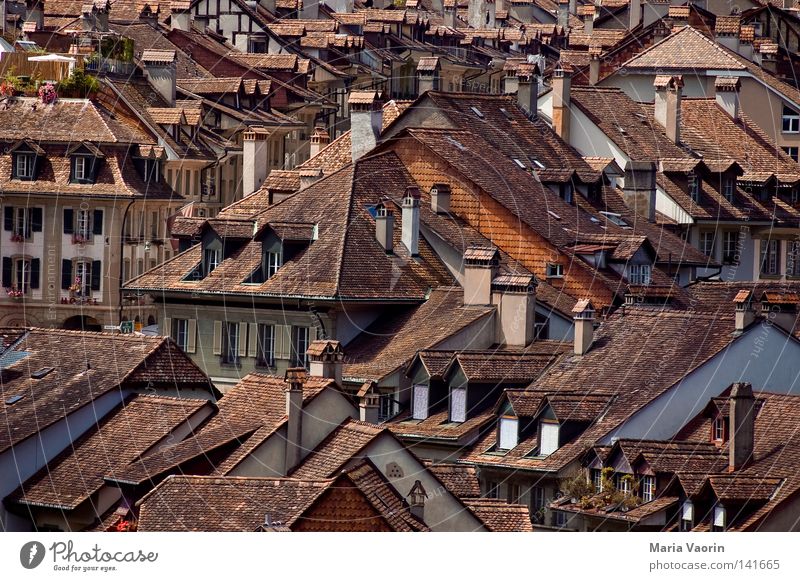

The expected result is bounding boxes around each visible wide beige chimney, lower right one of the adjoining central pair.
[492,274,537,347]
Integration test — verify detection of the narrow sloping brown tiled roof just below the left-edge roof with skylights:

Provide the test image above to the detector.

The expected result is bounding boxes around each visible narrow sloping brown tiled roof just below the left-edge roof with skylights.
[11,395,210,510]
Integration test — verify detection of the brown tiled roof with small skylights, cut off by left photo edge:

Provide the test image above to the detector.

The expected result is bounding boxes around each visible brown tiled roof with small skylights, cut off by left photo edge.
[0,329,211,451]
